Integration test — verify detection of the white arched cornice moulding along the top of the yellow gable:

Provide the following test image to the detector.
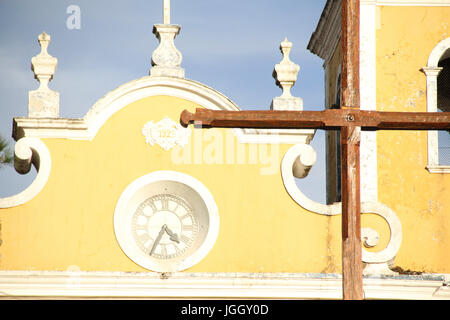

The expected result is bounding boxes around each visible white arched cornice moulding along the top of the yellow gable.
[13,76,314,144]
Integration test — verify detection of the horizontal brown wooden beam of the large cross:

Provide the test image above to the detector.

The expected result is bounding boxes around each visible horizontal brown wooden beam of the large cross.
[180,106,450,131]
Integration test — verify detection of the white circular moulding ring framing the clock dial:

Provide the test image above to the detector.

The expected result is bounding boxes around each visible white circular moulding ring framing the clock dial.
[114,171,220,272]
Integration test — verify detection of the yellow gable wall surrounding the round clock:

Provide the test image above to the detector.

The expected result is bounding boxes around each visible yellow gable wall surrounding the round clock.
[0,96,340,272]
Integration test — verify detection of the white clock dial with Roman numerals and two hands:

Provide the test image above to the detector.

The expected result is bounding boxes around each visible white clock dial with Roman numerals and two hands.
[131,194,199,259]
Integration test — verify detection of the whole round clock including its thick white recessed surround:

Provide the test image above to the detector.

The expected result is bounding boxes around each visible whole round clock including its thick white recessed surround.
[114,171,219,272]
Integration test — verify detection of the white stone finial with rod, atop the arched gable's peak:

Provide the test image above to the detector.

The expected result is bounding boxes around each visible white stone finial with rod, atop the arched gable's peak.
[150,0,184,78]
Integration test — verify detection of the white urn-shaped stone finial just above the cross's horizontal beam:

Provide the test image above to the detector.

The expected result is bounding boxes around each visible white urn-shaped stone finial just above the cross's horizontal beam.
[270,38,303,110]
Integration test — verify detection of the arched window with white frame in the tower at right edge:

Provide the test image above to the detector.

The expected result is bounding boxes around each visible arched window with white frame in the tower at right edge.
[422,38,450,173]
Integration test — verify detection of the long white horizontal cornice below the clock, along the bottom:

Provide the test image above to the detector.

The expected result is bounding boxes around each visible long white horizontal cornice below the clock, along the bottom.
[0,271,450,300]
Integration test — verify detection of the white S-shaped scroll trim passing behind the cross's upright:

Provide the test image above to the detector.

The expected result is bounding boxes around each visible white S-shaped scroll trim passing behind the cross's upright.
[281,144,402,274]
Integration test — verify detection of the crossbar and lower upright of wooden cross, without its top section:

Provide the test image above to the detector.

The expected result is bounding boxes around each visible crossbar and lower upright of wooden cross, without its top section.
[180,108,450,300]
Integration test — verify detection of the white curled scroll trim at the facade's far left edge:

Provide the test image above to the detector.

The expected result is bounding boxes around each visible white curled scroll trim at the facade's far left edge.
[0,138,52,208]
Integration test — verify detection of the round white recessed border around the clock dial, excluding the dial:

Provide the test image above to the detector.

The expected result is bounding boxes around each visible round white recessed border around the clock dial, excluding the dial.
[114,171,219,272]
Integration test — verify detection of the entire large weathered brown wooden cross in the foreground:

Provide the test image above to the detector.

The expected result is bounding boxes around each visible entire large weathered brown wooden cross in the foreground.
[180,0,450,300]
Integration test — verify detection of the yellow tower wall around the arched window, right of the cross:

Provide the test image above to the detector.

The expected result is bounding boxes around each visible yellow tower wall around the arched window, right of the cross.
[376,7,450,273]
